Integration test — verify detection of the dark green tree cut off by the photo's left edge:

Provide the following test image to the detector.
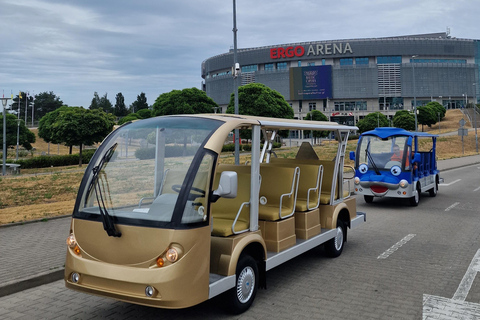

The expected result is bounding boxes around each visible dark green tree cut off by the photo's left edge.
[0,113,35,150]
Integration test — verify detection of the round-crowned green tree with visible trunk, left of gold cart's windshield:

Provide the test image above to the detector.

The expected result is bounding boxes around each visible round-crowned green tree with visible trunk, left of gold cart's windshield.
[39,107,115,166]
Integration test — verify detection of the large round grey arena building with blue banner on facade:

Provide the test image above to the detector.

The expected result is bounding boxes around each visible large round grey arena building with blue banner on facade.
[202,32,480,125]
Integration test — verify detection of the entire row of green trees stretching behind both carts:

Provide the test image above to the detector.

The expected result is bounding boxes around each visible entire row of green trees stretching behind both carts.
[0,83,454,168]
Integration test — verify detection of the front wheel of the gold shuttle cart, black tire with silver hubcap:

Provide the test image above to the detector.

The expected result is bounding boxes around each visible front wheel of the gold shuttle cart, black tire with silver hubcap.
[228,255,259,314]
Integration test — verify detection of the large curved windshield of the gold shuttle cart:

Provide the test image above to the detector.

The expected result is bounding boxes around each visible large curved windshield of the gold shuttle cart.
[74,117,222,228]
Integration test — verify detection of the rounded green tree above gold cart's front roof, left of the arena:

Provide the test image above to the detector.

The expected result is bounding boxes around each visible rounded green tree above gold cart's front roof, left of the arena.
[153,88,218,116]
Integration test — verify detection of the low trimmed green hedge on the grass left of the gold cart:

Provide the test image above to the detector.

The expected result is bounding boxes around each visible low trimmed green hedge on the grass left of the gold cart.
[9,149,95,169]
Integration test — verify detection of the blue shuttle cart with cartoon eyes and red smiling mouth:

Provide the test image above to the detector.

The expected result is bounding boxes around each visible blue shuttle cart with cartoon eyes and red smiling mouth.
[350,128,443,206]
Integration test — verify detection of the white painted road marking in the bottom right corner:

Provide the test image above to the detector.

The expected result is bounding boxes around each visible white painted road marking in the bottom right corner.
[422,250,480,320]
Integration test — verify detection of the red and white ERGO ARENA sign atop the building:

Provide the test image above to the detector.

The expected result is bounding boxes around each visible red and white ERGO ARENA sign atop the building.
[270,42,353,59]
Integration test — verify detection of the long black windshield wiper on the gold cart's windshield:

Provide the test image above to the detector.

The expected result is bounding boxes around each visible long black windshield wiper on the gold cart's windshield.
[88,143,122,237]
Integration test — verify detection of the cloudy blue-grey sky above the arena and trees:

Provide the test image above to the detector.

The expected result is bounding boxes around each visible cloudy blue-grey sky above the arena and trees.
[0,0,480,108]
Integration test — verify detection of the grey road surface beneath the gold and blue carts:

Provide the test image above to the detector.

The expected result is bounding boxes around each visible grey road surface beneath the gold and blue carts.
[0,165,480,319]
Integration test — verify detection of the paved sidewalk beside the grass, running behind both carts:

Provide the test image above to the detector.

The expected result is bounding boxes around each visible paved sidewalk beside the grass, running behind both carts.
[0,155,480,297]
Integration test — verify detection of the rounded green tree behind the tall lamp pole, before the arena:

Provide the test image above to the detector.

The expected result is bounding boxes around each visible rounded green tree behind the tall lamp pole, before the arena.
[227,83,294,119]
